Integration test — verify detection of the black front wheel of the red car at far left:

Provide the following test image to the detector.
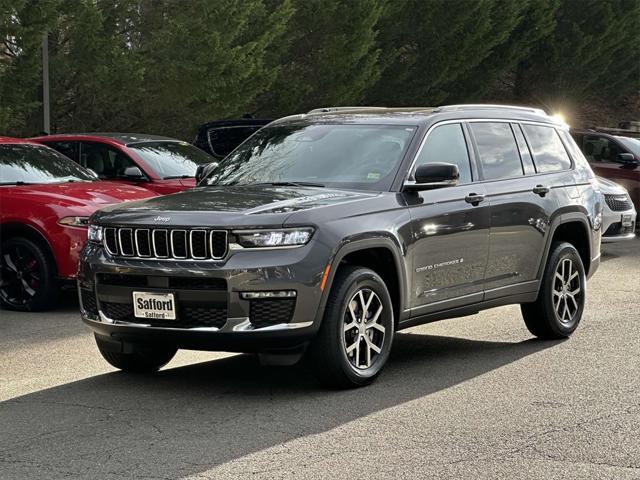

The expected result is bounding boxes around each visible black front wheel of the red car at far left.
[0,237,56,311]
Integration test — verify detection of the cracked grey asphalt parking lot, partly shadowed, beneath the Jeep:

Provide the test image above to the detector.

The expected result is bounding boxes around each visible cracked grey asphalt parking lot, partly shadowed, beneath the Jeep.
[0,240,640,479]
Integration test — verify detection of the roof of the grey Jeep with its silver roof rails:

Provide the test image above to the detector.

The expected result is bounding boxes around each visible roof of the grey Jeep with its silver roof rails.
[275,104,562,125]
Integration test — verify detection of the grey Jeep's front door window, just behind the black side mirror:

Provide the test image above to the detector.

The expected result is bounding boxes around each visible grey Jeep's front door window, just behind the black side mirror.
[416,123,471,183]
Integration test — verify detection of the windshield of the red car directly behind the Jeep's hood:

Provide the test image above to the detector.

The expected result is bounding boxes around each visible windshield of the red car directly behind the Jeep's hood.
[127,142,215,179]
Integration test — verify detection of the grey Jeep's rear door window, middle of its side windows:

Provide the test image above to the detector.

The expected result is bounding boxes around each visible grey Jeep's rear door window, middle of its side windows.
[470,122,523,180]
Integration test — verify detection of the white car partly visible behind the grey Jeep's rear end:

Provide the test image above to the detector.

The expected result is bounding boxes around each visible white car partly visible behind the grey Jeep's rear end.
[598,177,636,243]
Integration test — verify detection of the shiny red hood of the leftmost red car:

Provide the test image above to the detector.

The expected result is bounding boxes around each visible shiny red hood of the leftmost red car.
[14,181,156,211]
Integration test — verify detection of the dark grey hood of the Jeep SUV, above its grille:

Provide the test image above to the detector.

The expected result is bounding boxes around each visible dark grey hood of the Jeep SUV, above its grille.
[94,185,378,226]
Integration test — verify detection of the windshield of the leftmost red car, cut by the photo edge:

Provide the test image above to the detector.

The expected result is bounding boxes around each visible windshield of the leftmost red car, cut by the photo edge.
[0,143,96,185]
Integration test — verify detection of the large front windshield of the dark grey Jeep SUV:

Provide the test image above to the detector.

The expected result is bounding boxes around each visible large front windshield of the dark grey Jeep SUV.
[202,124,416,191]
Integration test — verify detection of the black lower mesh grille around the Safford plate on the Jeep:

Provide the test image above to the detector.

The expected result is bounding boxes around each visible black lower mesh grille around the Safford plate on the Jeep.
[100,302,227,328]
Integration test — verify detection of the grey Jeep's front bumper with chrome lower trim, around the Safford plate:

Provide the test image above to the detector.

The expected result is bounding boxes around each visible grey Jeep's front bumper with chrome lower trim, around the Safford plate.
[78,240,330,352]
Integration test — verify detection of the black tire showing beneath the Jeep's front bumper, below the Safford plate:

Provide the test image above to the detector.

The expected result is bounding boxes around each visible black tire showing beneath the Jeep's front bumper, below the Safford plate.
[96,335,178,373]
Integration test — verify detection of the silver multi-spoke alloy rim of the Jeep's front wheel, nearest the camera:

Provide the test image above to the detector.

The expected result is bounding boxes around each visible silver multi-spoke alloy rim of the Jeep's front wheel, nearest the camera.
[343,288,386,370]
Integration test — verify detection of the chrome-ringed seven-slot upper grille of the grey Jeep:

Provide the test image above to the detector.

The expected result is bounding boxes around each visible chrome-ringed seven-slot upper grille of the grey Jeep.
[104,227,227,260]
